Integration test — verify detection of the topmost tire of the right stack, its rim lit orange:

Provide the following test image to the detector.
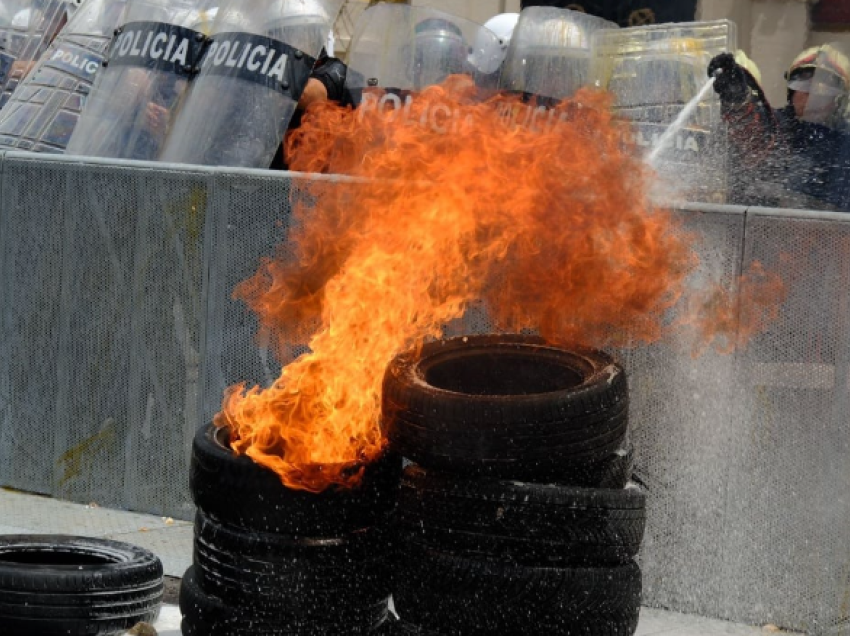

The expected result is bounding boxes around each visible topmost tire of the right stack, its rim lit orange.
[381,335,628,485]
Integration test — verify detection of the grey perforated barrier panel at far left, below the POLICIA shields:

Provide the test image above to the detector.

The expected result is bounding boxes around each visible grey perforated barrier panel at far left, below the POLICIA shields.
[0,156,209,517]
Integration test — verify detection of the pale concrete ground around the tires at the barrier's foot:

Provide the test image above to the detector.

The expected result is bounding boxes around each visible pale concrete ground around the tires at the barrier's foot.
[0,488,802,636]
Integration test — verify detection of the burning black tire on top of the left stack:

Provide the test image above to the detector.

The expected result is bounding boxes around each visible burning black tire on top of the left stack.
[189,423,402,537]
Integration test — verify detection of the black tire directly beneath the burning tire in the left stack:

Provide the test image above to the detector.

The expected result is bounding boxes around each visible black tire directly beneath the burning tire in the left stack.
[193,511,390,618]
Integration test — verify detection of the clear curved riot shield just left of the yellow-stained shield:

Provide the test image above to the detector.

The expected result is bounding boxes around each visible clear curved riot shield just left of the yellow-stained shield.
[501,7,617,103]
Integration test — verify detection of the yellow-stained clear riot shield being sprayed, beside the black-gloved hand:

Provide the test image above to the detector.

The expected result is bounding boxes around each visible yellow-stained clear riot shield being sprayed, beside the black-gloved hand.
[593,20,737,203]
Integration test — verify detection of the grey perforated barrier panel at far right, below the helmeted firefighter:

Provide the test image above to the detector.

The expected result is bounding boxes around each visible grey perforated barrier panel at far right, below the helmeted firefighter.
[720,209,850,634]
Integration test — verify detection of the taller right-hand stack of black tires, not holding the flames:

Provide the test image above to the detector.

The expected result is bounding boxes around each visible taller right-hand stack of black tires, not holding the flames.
[382,335,645,636]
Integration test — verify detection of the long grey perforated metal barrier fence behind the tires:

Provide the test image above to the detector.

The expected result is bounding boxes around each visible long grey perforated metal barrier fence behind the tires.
[0,153,850,634]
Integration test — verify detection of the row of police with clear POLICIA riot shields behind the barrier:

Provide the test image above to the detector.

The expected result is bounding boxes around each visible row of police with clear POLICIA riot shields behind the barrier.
[0,0,840,210]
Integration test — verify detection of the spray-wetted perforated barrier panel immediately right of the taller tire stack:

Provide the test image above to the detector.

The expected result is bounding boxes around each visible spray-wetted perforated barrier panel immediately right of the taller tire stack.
[616,208,745,616]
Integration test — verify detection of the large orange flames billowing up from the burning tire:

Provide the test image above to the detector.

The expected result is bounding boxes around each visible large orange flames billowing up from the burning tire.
[216,79,780,491]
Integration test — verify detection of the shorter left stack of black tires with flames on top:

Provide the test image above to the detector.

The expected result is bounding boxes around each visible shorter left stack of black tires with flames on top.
[180,424,402,636]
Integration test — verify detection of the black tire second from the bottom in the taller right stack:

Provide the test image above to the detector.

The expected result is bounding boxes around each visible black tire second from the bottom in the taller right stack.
[397,464,646,566]
